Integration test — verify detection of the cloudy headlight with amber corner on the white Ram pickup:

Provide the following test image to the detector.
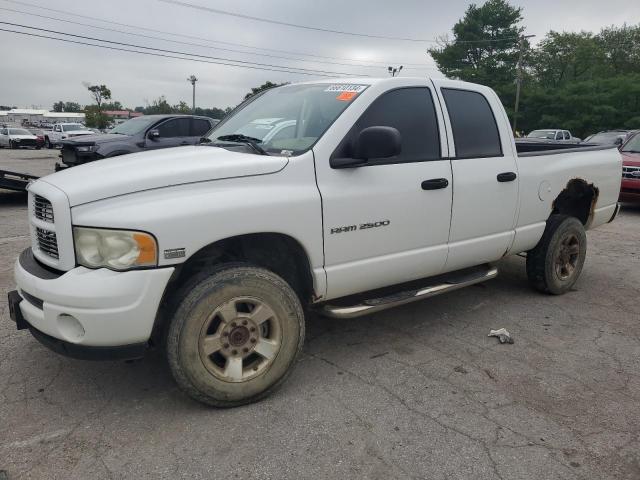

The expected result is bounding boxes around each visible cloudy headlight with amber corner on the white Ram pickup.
[73,227,158,270]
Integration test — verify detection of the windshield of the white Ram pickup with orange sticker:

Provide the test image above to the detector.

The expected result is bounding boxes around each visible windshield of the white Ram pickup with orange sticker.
[209,84,367,155]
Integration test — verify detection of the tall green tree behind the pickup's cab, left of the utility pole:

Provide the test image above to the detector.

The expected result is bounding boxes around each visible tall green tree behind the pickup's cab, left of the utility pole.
[429,0,529,112]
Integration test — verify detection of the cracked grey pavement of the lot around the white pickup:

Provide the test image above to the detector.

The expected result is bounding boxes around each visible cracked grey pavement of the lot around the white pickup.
[0,150,640,480]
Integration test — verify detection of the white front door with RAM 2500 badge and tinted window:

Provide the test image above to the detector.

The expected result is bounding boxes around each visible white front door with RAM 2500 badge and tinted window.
[314,81,452,298]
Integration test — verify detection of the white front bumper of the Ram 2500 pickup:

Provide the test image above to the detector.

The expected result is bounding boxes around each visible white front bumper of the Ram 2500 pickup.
[14,249,174,347]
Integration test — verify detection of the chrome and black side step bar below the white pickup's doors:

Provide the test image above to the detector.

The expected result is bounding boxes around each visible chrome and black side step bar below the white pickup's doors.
[320,265,498,319]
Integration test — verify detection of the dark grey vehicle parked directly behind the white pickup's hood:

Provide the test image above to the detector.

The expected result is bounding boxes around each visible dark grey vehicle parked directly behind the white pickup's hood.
[56,115,218,171]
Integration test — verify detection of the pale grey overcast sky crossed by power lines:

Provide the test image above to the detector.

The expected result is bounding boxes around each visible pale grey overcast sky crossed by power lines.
[0,0,640,108]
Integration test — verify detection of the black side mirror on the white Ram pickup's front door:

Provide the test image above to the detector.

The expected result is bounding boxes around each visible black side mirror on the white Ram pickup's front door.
[329,126,402,168]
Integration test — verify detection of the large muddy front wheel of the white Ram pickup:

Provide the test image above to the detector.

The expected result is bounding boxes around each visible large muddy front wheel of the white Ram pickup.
[166,264,304,407]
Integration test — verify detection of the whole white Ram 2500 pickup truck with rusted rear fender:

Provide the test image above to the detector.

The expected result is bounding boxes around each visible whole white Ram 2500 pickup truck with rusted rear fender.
[9,77,621,406]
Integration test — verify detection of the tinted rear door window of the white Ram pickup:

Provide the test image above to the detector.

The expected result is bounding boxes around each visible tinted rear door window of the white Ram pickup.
[442,88,502,158]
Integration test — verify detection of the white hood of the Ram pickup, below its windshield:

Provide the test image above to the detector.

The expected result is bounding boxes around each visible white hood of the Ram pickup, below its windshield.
[38,145,288,207]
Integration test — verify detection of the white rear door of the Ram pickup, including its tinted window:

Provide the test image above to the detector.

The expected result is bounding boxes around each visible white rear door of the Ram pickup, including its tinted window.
[434,80,518,271]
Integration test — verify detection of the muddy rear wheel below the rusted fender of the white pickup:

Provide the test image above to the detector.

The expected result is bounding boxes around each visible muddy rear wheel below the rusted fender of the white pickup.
[527,215,587,295]
